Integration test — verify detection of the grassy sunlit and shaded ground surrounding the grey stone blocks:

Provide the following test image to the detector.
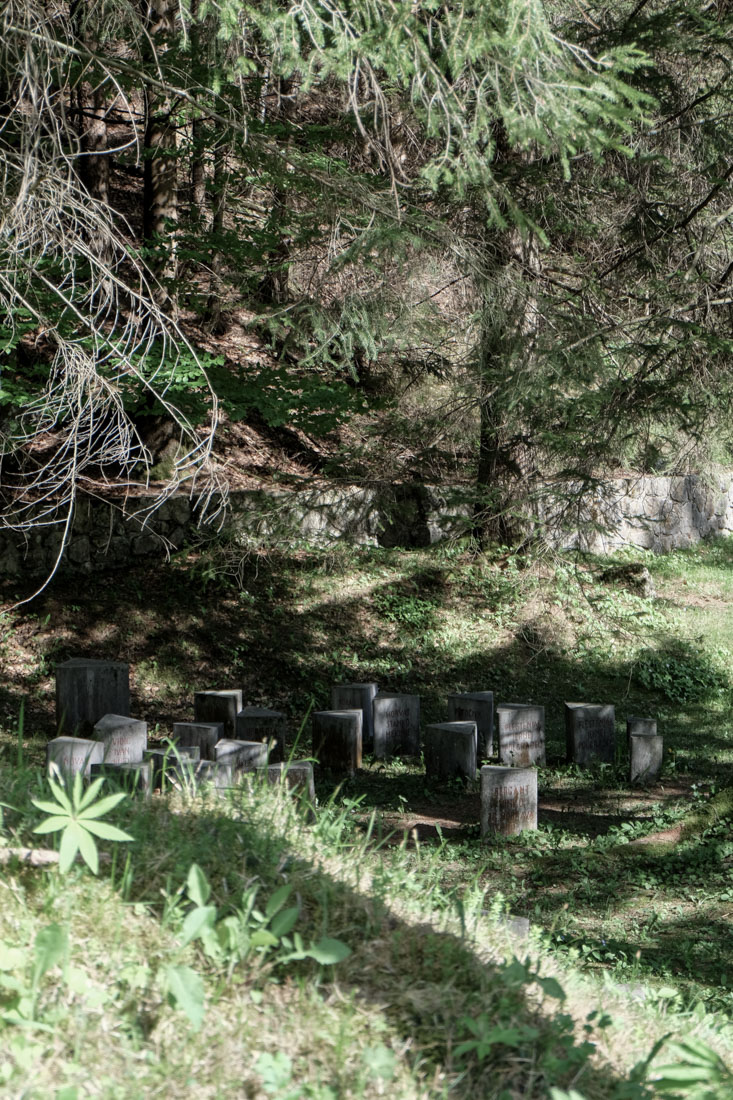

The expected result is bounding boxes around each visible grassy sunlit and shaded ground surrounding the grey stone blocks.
[0,541,733,1100]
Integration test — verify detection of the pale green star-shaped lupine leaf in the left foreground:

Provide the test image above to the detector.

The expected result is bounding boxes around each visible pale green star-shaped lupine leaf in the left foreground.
[31,772,133,875]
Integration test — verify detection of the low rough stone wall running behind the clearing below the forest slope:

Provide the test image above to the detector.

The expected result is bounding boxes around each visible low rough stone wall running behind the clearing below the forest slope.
[0,472,733,576]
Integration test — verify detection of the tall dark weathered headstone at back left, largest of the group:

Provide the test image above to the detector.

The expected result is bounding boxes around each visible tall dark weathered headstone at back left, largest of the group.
[56,657,130,735]
